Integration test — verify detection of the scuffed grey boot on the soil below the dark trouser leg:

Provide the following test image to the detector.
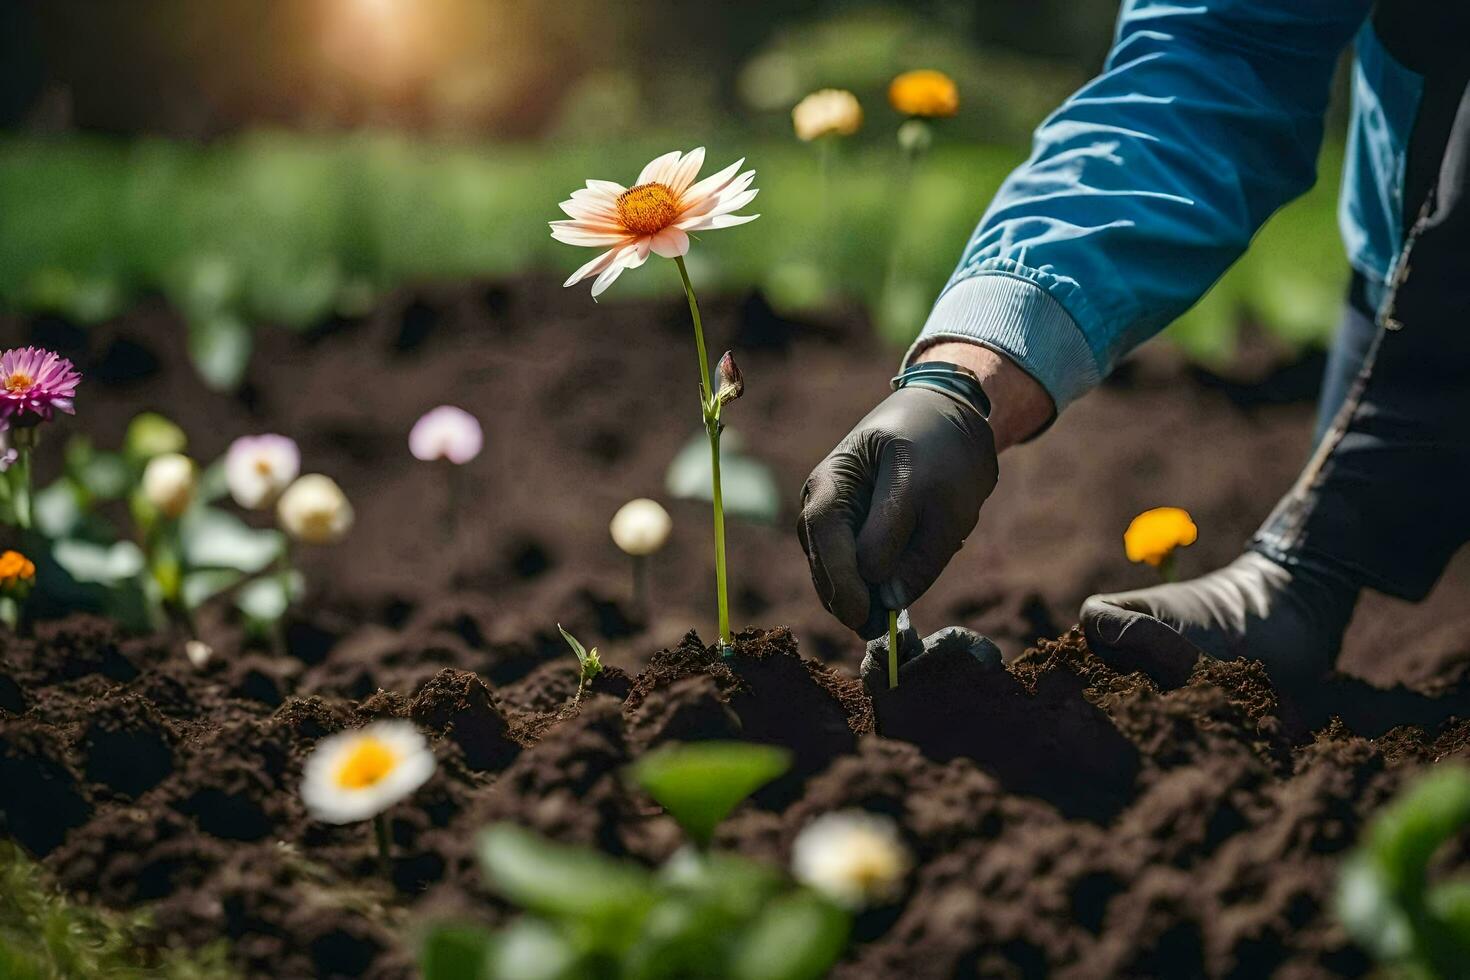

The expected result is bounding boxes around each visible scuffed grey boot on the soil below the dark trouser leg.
[1082,551,1358,688]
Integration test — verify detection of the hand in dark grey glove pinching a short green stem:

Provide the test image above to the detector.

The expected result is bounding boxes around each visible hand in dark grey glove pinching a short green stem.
[797,386,998,639]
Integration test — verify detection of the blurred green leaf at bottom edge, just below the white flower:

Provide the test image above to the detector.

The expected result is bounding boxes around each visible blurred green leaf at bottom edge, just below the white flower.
[729,892,851,980]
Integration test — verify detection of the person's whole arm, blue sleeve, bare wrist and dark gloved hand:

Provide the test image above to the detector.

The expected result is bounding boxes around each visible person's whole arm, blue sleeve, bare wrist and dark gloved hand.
[798,0,1372,638]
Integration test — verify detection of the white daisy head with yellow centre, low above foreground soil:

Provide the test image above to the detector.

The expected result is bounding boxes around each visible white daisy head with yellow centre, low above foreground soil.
[301,721,434,823]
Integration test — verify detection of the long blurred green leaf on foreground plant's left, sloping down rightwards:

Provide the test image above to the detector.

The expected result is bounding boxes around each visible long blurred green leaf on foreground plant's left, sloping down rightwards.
[479,823,653,933]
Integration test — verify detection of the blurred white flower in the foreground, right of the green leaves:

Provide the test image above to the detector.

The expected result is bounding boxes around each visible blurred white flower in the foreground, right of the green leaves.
[791,810,913,908]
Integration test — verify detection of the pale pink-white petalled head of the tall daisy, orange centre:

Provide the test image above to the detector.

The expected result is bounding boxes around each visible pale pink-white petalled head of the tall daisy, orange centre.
[551,147,760,298]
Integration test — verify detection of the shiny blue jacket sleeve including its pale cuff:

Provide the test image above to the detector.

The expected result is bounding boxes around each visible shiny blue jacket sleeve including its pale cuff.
[908,0,1372,410]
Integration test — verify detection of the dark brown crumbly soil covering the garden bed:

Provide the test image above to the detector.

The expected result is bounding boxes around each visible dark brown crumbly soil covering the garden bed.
[0,285,1470,977]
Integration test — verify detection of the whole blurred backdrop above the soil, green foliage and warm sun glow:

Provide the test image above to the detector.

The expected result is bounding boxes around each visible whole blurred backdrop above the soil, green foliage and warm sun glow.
[0,0,1344,385]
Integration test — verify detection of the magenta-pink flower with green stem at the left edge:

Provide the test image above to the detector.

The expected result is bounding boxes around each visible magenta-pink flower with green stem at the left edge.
[0,347,82,530]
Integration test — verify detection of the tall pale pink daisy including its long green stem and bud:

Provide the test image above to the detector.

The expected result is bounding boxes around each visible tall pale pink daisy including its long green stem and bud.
[551,147,759,654]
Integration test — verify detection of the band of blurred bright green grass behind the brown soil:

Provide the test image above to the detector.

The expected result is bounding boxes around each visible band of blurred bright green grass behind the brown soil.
[0,132,1345,371]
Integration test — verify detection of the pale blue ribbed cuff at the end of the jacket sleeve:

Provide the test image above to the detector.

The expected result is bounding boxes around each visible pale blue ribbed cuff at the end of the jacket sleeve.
[904,272,1103,411]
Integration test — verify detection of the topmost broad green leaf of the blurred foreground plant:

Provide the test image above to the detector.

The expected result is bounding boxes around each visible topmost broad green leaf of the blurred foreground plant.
[628,742,791,845]
